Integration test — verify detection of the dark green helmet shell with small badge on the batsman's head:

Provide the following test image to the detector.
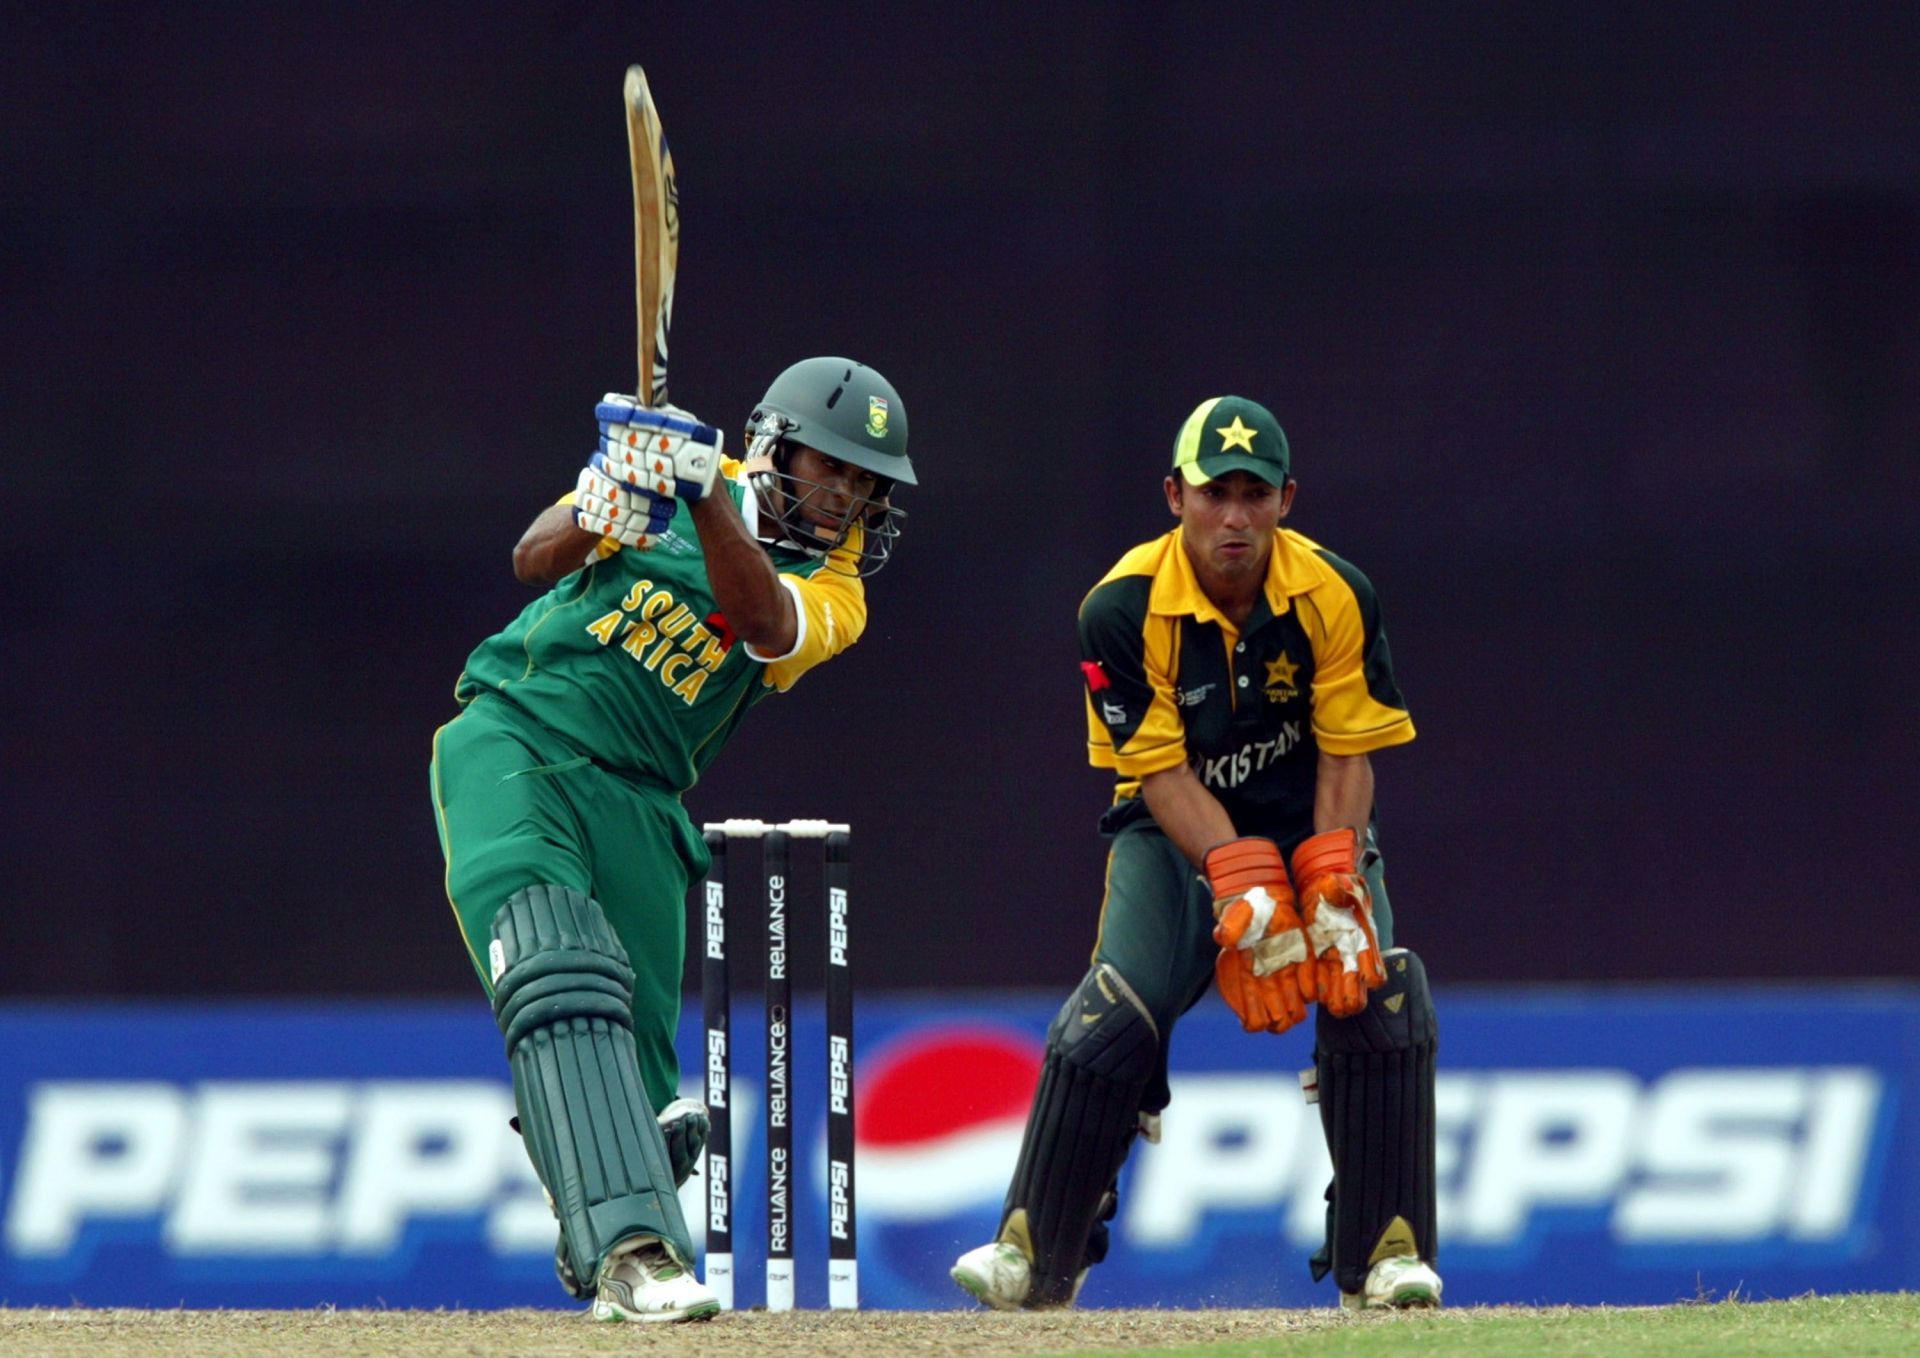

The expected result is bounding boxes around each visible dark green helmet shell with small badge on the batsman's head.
[747,357,920,486]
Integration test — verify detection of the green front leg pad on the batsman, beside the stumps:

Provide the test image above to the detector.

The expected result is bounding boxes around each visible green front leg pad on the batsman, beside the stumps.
[490,885,693,1281]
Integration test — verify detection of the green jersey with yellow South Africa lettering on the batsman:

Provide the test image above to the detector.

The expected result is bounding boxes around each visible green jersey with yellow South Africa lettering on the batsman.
[455,459,866,791]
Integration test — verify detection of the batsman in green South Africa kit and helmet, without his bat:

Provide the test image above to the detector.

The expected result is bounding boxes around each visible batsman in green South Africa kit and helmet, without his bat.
[432,357,914,1320]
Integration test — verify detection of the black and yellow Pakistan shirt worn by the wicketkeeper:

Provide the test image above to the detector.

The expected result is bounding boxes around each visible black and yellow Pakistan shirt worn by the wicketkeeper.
[1079,528,1413,843]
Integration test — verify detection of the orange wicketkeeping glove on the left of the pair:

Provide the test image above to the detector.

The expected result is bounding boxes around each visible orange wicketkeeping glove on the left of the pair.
[1206,837,1317,1033]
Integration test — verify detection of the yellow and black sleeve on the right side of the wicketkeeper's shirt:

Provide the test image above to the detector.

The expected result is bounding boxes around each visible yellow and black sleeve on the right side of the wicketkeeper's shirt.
[1298,563,1413,755]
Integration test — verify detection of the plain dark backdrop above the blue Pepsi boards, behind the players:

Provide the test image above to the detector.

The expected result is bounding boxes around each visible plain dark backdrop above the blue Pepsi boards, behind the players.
[0,4,1920,997]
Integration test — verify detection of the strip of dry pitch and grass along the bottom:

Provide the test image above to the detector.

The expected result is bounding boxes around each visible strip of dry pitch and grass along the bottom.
[0,1293,1920,1358]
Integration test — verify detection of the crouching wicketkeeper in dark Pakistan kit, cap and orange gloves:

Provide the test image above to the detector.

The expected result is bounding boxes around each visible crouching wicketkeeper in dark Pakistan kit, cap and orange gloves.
[952,396,1440,1310]
